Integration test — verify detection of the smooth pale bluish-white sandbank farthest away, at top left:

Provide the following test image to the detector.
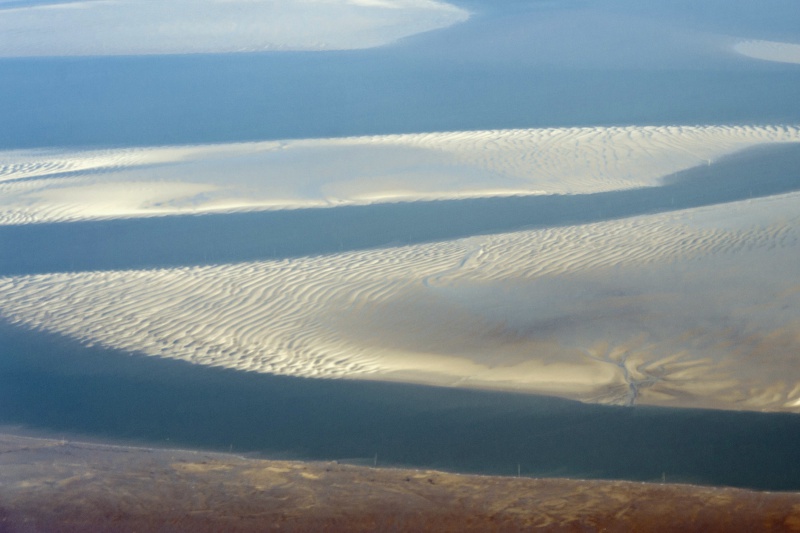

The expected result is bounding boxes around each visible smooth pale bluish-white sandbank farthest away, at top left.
[0,0,469,57]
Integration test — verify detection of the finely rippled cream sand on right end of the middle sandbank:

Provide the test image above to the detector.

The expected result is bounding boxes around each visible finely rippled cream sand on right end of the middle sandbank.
[382,126,800,194]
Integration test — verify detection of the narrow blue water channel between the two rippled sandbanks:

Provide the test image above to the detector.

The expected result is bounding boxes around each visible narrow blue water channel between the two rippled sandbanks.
[0,144,800,275]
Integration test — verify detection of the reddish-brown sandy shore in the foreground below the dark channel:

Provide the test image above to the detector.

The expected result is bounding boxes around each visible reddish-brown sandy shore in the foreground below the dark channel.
[0,435,800,532]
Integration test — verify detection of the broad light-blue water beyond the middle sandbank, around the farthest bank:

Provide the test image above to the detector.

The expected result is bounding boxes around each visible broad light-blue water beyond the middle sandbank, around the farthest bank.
[0,0,800,148]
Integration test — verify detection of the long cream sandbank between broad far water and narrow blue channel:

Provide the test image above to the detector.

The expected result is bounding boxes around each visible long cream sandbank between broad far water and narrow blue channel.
[0,126,800,224]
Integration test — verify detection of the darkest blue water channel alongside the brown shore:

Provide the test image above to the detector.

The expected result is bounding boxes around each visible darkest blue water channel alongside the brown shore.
[0,324,800,490]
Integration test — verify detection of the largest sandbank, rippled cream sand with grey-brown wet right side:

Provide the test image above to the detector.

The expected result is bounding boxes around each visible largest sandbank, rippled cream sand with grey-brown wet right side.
[0,193,800,412]
